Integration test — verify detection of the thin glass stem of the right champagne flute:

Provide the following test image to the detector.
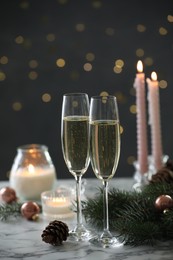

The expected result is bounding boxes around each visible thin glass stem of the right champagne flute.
[103,181,109,232]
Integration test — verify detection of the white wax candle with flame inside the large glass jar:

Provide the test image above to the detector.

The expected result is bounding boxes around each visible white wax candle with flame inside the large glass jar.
[10,164,56,200]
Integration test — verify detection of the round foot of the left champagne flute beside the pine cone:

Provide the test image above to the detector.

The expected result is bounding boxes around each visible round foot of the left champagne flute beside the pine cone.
[68,225,95,241]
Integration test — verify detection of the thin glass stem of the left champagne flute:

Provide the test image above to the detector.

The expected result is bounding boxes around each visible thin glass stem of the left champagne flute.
[75,176,82,227]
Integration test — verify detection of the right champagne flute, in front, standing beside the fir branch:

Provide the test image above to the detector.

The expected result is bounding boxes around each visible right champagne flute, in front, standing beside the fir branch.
[89,96,122,248]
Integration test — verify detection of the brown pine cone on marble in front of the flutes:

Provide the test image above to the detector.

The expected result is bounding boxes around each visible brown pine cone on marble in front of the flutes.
[41,220,69,246]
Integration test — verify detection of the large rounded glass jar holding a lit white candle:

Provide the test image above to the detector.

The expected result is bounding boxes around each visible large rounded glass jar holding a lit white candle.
[10,144,56,200]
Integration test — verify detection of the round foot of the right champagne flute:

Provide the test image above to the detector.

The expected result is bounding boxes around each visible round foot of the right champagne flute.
[89,236,123,248]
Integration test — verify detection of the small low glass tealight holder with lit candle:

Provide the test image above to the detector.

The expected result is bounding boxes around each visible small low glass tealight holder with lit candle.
[41,188,74,219]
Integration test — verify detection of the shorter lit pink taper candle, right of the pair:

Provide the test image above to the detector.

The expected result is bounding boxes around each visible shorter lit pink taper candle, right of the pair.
[147,72,163,171]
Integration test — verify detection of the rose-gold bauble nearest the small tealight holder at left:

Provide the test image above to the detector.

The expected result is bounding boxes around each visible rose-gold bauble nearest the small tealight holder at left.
[21,201,40,220]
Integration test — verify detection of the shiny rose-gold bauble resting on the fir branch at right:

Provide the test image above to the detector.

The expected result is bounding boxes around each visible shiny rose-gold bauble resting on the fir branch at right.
[155,195,173,211]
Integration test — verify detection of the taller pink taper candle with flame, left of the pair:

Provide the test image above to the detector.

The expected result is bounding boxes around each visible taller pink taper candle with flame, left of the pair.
[134,61,148,174]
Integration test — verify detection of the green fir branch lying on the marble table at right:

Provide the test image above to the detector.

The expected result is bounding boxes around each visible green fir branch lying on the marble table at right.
[83,182,173,246]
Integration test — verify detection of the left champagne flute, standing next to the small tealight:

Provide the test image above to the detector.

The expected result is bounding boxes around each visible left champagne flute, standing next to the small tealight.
[61,93,91,241]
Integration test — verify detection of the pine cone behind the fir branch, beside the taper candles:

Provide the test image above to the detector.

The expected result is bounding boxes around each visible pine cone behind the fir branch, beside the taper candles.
[150,167,173,183]
